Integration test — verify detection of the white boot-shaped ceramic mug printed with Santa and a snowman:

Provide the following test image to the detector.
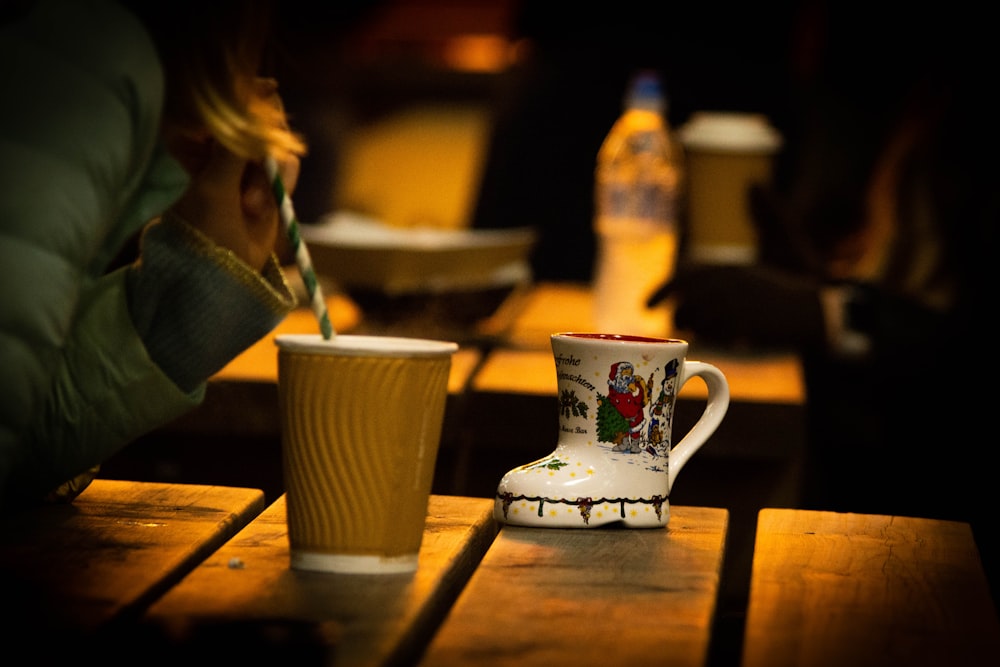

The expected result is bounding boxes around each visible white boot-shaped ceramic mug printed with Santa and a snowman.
[494,333,729,528]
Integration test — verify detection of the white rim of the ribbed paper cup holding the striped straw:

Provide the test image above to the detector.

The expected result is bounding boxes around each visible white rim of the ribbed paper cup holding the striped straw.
[274,334,458,357]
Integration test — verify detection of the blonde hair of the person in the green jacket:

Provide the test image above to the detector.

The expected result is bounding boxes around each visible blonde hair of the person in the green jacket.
[127,0,306,160]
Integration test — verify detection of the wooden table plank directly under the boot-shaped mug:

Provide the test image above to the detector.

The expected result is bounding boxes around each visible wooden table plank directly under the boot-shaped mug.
[421,507,728,667]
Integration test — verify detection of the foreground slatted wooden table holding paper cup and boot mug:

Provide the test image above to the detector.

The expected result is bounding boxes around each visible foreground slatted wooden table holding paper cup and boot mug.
[9,480,1000,667]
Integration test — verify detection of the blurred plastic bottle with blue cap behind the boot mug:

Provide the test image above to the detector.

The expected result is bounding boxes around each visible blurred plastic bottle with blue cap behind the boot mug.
[593,71,682,336]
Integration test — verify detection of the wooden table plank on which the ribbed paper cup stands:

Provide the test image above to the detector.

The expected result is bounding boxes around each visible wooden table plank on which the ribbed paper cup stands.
[147,495,497,667]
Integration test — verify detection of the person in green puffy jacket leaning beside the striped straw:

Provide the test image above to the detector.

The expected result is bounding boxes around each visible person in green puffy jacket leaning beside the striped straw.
[0,0,305,505]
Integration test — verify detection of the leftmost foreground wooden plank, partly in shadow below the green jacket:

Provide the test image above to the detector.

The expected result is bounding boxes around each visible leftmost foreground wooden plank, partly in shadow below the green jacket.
[0,479,264,639]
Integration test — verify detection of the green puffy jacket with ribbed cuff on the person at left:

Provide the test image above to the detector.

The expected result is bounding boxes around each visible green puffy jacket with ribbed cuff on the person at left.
[0,0,295,503]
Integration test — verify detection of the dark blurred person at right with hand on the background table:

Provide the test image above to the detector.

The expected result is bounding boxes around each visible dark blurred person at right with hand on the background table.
[651,7,1000,590]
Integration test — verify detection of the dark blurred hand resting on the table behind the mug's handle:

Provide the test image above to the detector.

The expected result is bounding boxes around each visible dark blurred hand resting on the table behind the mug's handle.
[649,264,825,347]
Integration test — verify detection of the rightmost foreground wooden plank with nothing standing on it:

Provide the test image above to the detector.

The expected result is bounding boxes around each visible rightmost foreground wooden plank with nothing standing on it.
[743,509,1000,667]
